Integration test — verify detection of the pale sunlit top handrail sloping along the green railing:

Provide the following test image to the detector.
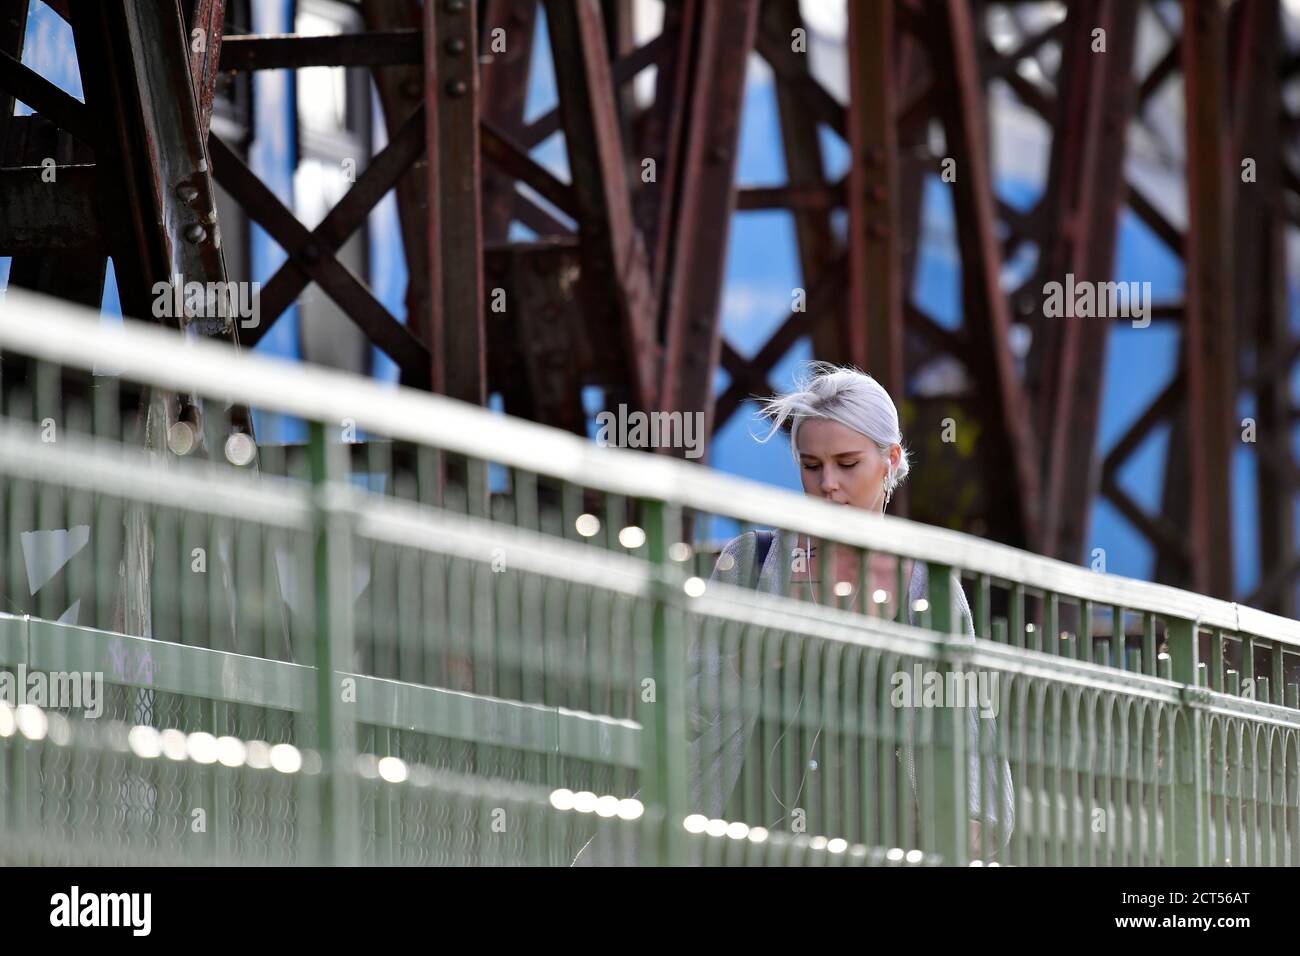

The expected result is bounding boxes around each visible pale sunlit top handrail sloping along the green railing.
[0,290,1300,646]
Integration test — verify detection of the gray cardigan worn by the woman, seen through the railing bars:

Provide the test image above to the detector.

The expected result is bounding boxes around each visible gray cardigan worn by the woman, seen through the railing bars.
[575,531,1015,866]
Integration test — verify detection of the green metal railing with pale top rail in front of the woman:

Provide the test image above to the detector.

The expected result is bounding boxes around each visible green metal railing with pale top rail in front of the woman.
[0,291,1300,865]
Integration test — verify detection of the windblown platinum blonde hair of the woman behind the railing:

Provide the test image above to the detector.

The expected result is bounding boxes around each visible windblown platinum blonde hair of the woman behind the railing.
[758,362,911,499]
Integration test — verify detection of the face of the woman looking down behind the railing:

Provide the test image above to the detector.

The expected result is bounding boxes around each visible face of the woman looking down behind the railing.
[800,419,900,511]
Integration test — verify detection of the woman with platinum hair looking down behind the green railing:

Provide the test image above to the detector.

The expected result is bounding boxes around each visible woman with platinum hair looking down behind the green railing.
[575,363,1014,865]
